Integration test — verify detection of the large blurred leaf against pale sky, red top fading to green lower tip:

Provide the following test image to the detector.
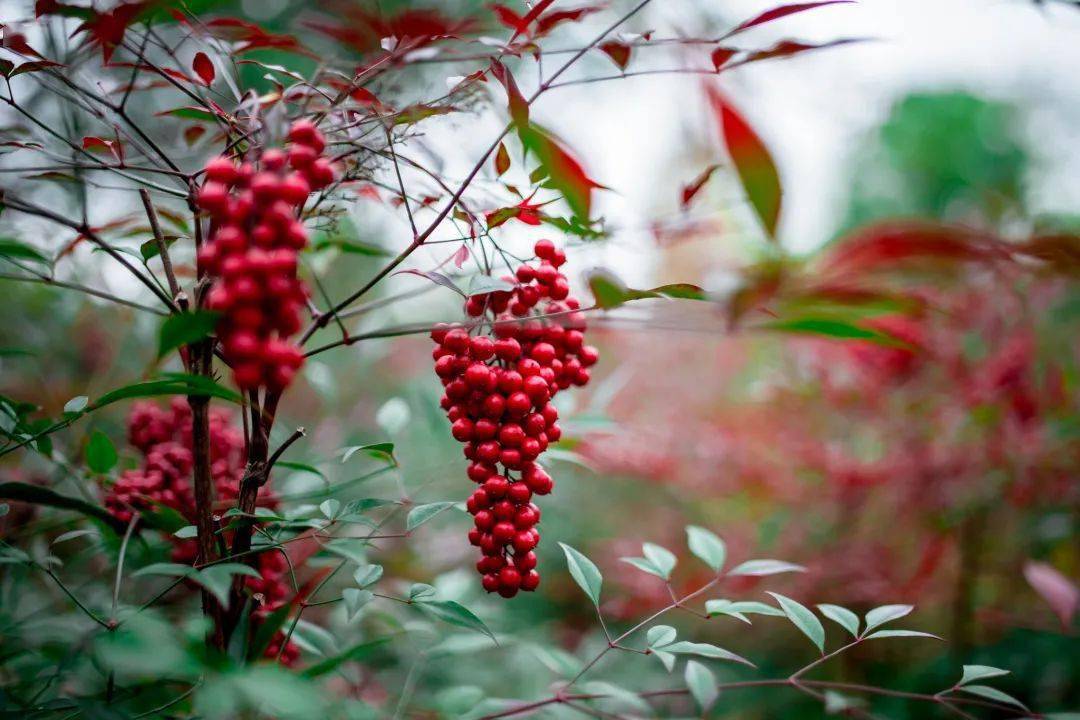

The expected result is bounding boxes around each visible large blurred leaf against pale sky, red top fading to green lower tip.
[706,85,783,239]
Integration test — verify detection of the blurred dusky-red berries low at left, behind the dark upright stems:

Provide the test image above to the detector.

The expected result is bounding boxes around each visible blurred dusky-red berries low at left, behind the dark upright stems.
[105,398,299,664]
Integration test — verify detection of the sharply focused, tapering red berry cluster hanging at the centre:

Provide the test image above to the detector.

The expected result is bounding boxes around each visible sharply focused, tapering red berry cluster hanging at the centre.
[431,240,597,598]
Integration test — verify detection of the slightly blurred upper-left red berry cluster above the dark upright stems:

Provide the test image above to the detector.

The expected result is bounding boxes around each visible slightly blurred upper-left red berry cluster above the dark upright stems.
[199,120,334,391]
